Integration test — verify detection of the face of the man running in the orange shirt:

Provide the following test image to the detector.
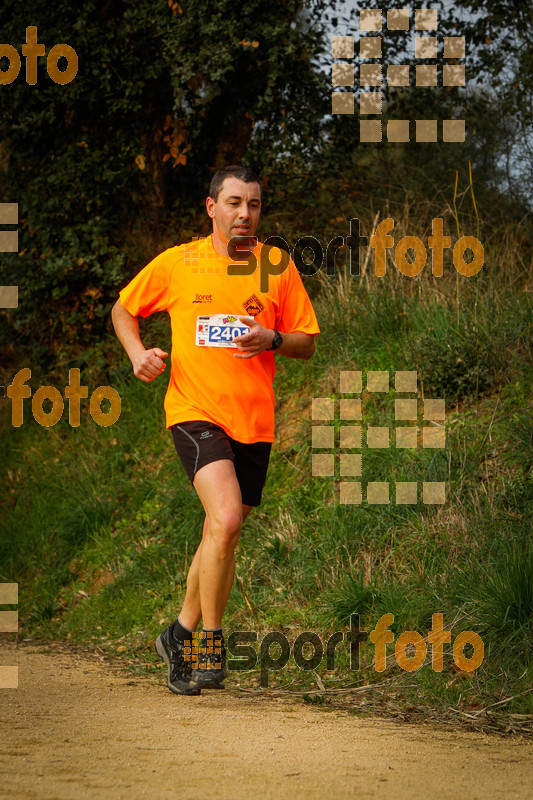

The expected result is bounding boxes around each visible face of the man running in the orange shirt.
[206,178,261,252]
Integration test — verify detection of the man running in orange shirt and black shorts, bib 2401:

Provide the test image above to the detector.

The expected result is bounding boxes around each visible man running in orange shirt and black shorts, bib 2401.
[112,166,320,695]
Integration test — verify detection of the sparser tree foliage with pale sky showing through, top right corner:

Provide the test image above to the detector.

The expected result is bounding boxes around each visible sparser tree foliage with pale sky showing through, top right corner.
[350,0,533,203]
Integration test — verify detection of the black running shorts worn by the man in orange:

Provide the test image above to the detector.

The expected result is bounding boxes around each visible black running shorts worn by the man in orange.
[170,419,272,506]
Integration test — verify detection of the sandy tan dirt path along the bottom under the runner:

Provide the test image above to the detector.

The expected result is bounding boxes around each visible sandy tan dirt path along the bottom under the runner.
[0,640,533,800]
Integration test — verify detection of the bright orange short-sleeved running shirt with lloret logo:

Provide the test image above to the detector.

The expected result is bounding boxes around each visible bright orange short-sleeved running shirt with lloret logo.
[120,236,320,444]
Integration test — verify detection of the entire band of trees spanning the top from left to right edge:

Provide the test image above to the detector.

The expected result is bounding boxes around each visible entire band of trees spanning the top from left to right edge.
[0,0,533,359]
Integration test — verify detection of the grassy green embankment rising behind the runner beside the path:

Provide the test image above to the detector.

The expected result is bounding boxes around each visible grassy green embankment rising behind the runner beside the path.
[0,197,533,730]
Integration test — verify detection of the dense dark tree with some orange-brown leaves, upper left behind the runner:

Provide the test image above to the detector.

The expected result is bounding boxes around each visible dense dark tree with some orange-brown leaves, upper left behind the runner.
[0,0,328,356]
